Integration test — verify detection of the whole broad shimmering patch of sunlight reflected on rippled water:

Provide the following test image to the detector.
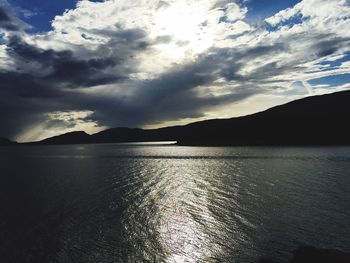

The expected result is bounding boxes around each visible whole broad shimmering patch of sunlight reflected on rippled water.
[119,148,255,263]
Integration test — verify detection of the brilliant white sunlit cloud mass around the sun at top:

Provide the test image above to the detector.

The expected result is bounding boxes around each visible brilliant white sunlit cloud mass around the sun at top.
[27,0,250,76]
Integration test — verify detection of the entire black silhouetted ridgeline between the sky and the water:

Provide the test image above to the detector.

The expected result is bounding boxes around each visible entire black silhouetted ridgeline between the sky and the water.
[26,91,350,146]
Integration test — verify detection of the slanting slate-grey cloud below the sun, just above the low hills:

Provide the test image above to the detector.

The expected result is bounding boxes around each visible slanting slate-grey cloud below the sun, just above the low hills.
[64,59,223,127]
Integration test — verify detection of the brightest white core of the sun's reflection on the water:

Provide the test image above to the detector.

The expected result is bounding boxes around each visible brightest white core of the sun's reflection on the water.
[159,168,210,263]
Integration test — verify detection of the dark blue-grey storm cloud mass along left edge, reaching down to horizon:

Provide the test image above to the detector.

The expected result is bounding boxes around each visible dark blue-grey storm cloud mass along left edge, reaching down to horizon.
[0,32,143,138]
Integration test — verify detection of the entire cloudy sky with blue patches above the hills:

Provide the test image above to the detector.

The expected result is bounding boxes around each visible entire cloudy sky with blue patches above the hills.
[0,0,350,142]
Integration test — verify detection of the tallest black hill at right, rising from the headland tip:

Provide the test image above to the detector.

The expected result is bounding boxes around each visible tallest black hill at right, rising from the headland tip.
[179,91,350,145]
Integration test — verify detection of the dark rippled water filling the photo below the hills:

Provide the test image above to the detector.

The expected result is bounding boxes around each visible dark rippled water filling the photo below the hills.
[0,145,350,263]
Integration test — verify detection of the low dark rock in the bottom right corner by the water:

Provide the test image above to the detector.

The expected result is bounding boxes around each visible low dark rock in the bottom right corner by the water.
[259,247,350,263]
